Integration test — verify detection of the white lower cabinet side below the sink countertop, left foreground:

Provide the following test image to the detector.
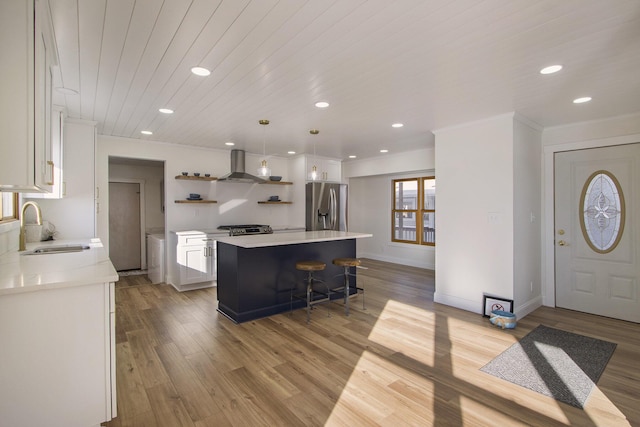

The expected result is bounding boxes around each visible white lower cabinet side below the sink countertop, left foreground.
[0,283,116,427]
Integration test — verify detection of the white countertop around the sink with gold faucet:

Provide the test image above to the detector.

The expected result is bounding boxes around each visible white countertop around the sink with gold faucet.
[0,239,118,295]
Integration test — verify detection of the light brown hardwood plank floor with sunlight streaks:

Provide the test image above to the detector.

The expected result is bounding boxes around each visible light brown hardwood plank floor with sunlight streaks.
[105,259,640,427]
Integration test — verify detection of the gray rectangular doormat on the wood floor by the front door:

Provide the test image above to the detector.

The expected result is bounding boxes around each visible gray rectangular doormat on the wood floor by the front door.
[480,325,616,408]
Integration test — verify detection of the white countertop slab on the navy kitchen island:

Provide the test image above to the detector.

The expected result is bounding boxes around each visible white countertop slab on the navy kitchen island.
[217,230,373,248]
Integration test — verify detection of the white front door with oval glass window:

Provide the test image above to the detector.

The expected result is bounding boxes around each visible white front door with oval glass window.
[554,143,640,323]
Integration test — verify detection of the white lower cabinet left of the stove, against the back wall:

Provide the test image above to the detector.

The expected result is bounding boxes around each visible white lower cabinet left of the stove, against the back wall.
[171,232,216,291]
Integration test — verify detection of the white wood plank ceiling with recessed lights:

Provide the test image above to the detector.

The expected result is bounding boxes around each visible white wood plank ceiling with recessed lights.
[50,0,640,158]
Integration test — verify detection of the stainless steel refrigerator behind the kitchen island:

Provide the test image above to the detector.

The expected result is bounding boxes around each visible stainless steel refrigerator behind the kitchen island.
[305,182,347,231]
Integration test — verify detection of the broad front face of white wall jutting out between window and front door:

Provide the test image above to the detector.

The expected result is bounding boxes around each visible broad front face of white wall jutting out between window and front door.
[434,114,514,312]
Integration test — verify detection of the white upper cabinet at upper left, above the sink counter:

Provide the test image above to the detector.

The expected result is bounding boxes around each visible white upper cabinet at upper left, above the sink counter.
[0,0,59,193]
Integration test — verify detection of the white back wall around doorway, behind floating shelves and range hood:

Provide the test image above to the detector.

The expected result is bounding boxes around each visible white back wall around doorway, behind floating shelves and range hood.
[96,135,302,248]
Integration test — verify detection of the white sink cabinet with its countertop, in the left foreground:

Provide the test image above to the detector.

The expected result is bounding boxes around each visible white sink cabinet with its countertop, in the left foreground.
[0,239,118,426]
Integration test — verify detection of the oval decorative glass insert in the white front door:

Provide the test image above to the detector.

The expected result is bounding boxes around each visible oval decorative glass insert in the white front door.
[580,170,625,253]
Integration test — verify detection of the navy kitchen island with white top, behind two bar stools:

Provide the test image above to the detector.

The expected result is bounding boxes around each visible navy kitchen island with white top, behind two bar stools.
[217,230,372,323]
